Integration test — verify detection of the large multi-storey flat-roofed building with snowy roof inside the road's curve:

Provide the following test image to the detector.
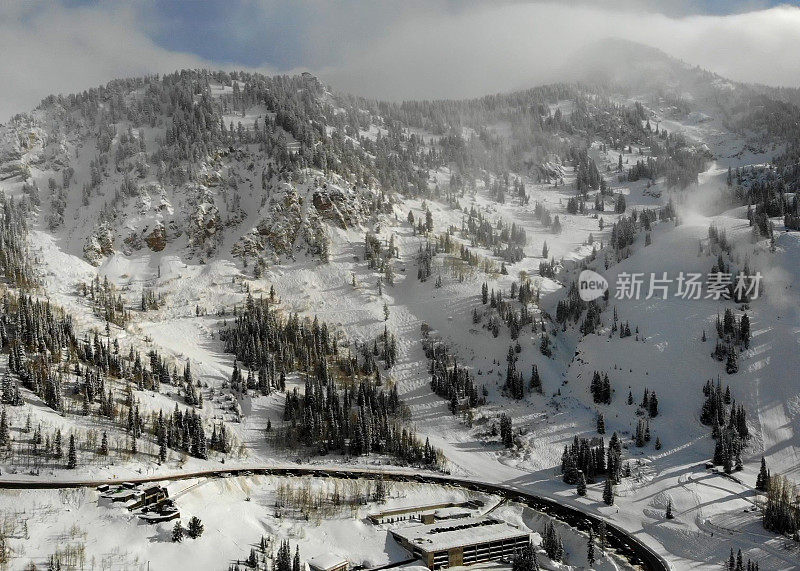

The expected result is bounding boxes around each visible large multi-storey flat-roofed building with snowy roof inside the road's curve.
[390,517,530,569]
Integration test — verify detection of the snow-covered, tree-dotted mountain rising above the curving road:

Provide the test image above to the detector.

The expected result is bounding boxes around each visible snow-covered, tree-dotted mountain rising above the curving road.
[0,41,800,568]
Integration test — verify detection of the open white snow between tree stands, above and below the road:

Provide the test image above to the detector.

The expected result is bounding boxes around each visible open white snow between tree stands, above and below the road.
[0,91,800,569]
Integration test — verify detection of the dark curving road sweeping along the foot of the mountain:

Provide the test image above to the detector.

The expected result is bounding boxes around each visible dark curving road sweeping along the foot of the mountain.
[0,465,670,571]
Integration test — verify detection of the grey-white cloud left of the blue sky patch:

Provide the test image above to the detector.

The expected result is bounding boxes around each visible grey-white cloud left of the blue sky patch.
[0,3,208,121]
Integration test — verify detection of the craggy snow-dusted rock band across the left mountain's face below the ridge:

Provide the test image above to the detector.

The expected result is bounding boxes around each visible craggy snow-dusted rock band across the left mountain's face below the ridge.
[0,102,388,267]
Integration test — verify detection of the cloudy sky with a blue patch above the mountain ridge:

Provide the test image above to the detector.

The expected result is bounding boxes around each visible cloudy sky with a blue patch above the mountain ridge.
[0,0,800,121]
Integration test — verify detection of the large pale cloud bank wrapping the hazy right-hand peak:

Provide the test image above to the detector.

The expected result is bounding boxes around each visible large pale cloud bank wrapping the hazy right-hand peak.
[320,2,800,99]
